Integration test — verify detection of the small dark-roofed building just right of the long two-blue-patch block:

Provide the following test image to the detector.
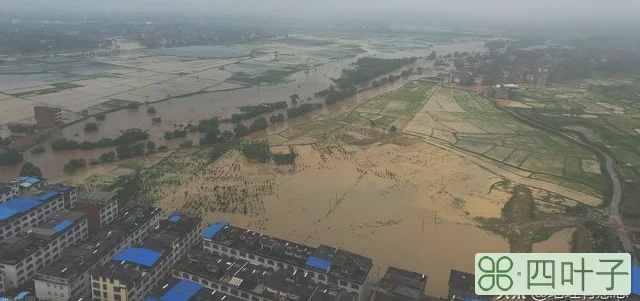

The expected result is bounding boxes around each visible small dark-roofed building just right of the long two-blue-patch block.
[371,267,427,301]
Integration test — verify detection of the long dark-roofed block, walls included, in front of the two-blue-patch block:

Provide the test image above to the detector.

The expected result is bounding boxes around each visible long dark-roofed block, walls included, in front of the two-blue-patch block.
[172,250,358,301]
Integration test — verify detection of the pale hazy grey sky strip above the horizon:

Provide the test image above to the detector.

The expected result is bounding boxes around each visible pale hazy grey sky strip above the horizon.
[0,0,640,18]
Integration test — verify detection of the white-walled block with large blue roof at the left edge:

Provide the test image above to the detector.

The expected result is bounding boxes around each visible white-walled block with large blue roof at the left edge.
[0,190,64,241]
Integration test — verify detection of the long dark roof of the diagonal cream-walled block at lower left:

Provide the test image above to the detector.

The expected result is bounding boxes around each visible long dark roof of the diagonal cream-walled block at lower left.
[38,205,160,280]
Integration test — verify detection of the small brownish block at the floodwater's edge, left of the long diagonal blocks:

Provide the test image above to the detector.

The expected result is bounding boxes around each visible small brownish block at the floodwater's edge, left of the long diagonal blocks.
[75,190,118,232]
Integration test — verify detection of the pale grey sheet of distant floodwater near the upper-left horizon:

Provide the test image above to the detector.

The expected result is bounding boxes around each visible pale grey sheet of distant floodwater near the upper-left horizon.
[147,45,251,58]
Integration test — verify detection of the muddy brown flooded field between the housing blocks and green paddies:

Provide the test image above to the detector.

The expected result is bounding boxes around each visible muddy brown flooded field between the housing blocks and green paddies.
[62,83,604,296]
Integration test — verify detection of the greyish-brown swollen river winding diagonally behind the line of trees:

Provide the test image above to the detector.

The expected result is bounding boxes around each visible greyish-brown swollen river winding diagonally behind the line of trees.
[0,42,483,181]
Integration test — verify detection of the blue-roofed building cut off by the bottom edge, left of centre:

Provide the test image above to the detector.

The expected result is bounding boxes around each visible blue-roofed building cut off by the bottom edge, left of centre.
[144,278,241,301]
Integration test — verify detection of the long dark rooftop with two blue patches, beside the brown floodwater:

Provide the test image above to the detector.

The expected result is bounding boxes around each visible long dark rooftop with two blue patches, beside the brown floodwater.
[203,222,373,283]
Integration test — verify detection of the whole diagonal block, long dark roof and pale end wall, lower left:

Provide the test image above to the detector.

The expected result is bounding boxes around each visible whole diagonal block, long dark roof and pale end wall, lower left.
[34,206,161,301]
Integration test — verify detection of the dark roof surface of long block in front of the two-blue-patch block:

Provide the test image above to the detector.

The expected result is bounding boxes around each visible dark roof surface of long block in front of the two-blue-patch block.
[179,250,356,301]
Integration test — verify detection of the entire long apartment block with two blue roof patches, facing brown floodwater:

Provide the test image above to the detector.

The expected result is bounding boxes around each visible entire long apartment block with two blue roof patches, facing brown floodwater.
[202,221,373,300]
